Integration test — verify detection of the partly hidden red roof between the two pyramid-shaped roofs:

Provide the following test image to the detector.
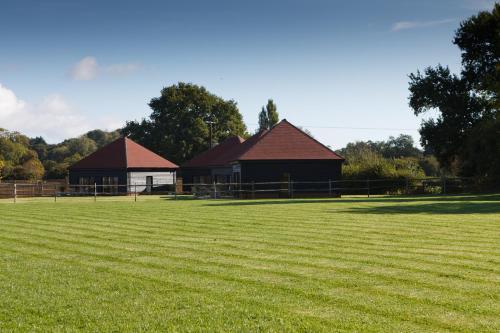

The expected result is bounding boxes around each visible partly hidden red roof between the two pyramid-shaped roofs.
[182,136,245,168]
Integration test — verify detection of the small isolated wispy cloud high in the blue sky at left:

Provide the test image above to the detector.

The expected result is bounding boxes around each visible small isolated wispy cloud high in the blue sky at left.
[70,56,142,81]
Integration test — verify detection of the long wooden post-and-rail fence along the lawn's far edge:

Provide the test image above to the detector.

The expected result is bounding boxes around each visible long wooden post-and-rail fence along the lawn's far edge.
[0,177,500,202]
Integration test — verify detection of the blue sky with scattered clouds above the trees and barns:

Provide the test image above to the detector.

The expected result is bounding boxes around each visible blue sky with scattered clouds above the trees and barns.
[0,0,494,148]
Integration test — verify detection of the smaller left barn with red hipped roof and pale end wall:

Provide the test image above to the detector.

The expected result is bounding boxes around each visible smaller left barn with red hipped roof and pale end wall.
[69,138,178,194]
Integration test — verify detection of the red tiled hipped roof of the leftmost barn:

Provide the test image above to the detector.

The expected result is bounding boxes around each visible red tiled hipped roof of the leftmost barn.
[70,138,178,169]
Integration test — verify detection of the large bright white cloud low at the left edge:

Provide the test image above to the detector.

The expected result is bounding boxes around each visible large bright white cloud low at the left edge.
[0,84,123,143]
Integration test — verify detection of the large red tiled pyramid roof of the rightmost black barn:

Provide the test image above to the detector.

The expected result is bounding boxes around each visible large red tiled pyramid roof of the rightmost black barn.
[235,119,344,161]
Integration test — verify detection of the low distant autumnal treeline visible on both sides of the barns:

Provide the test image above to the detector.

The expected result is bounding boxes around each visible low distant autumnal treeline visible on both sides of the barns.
[0,123,440,180]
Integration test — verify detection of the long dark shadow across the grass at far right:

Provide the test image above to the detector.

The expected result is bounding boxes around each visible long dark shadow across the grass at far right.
[205,194,500,214]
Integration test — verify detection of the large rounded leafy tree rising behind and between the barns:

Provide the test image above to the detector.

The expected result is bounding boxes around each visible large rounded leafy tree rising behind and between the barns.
[122,82,246,164]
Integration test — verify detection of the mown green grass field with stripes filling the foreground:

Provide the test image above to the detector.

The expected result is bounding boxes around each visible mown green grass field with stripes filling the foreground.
[0,195,500,332]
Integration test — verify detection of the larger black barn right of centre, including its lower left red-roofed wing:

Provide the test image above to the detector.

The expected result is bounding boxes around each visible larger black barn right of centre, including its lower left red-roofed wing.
[181,119,344,183]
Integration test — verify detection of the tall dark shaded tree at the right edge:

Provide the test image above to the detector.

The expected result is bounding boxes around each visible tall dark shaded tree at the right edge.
[409,4,500,176]
